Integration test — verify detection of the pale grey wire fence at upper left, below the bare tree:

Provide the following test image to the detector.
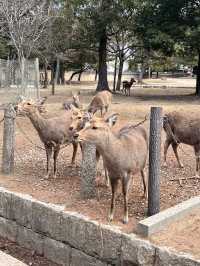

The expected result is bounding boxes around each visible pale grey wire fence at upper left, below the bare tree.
[0,58,40,104]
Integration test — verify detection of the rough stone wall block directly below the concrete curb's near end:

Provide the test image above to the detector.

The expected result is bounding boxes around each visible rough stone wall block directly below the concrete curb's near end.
[122,234,155,266]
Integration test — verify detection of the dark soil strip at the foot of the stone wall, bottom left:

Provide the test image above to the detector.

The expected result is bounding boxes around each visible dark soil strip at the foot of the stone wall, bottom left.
[0,237,58,266]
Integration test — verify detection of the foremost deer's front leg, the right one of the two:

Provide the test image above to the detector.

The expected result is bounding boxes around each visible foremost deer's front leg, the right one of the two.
[122,174,131,224]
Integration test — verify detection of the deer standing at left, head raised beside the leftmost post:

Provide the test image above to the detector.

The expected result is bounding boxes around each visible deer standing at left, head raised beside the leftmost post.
[17,100,78,179]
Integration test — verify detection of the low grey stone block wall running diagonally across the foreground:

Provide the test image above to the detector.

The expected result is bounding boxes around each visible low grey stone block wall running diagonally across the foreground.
[0,188,200,266]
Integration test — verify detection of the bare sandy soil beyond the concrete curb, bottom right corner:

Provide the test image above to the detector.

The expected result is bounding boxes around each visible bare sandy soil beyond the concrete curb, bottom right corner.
[150,209,200,259]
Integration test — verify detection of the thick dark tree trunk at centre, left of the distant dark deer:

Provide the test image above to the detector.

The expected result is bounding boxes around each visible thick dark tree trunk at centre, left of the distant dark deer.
[96,29,109,91]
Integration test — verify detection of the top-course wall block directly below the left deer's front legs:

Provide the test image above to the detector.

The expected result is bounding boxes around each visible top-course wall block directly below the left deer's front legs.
[31,201,63,240]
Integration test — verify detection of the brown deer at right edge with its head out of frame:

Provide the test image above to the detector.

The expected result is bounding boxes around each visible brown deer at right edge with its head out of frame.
[163,111,200,177]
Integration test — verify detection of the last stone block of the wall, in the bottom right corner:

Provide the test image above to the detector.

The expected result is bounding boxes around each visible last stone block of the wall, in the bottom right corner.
[154,247,200,266]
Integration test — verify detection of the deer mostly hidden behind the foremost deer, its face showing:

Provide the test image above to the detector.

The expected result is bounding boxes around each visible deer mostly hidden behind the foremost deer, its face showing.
[69,106,119,187]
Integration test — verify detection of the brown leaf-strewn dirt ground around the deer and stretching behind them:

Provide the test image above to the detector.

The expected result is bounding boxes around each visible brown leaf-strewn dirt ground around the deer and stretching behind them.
[0,79,200,256]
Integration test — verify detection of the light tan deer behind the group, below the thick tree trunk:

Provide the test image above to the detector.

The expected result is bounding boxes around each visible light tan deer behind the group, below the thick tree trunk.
[88,90,112,116]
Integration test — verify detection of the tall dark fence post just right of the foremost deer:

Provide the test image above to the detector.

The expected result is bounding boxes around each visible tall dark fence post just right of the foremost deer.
[148,107,162,216]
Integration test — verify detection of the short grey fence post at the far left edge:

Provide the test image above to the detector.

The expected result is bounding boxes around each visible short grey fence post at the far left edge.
[2,104,16,175]
